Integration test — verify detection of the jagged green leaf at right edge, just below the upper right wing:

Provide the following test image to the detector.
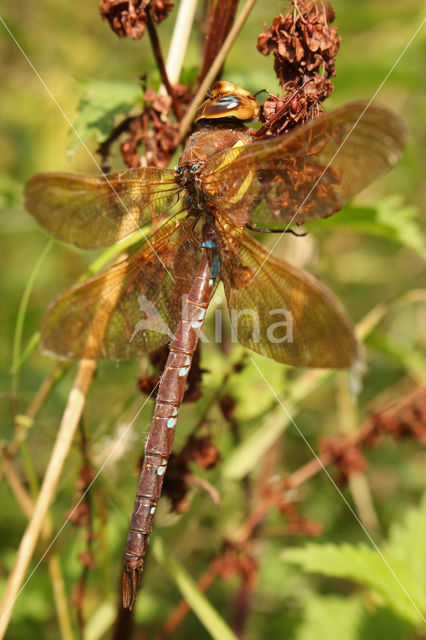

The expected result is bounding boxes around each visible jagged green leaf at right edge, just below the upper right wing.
[309,195,426,260]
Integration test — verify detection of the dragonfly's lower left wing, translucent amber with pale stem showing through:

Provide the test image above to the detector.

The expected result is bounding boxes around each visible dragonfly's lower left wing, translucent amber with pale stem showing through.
[41,218,199,360]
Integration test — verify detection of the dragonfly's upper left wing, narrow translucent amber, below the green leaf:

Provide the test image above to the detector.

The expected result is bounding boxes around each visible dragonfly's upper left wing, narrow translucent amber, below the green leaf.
[25,168,179,249]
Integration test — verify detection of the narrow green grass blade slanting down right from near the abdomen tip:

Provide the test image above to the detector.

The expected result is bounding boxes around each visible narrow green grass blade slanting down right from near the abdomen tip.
[151,536,238,640]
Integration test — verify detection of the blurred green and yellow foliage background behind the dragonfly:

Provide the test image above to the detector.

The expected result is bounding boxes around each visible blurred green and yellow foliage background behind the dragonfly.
[0,0,426,640]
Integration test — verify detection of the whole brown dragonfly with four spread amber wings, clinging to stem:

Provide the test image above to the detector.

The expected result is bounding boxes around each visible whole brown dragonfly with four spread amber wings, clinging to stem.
[26,82,405,608]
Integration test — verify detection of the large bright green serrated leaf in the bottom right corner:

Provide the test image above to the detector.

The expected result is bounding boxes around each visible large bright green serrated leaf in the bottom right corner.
[284,497,426,624]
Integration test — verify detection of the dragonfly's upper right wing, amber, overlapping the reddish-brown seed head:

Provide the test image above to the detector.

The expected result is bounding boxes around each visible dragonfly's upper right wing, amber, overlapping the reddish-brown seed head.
[203,103,406,229]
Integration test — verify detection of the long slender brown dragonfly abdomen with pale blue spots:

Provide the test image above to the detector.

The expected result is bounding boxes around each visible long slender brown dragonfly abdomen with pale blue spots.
[122,221,218,609]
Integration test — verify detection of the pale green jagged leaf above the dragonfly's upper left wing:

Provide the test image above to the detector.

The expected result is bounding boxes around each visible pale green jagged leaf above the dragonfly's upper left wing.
[68,79,143,154]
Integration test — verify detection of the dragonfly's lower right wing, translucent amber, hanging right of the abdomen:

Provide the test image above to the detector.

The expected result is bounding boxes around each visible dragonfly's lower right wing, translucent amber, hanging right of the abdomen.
[216,222,359,368]
